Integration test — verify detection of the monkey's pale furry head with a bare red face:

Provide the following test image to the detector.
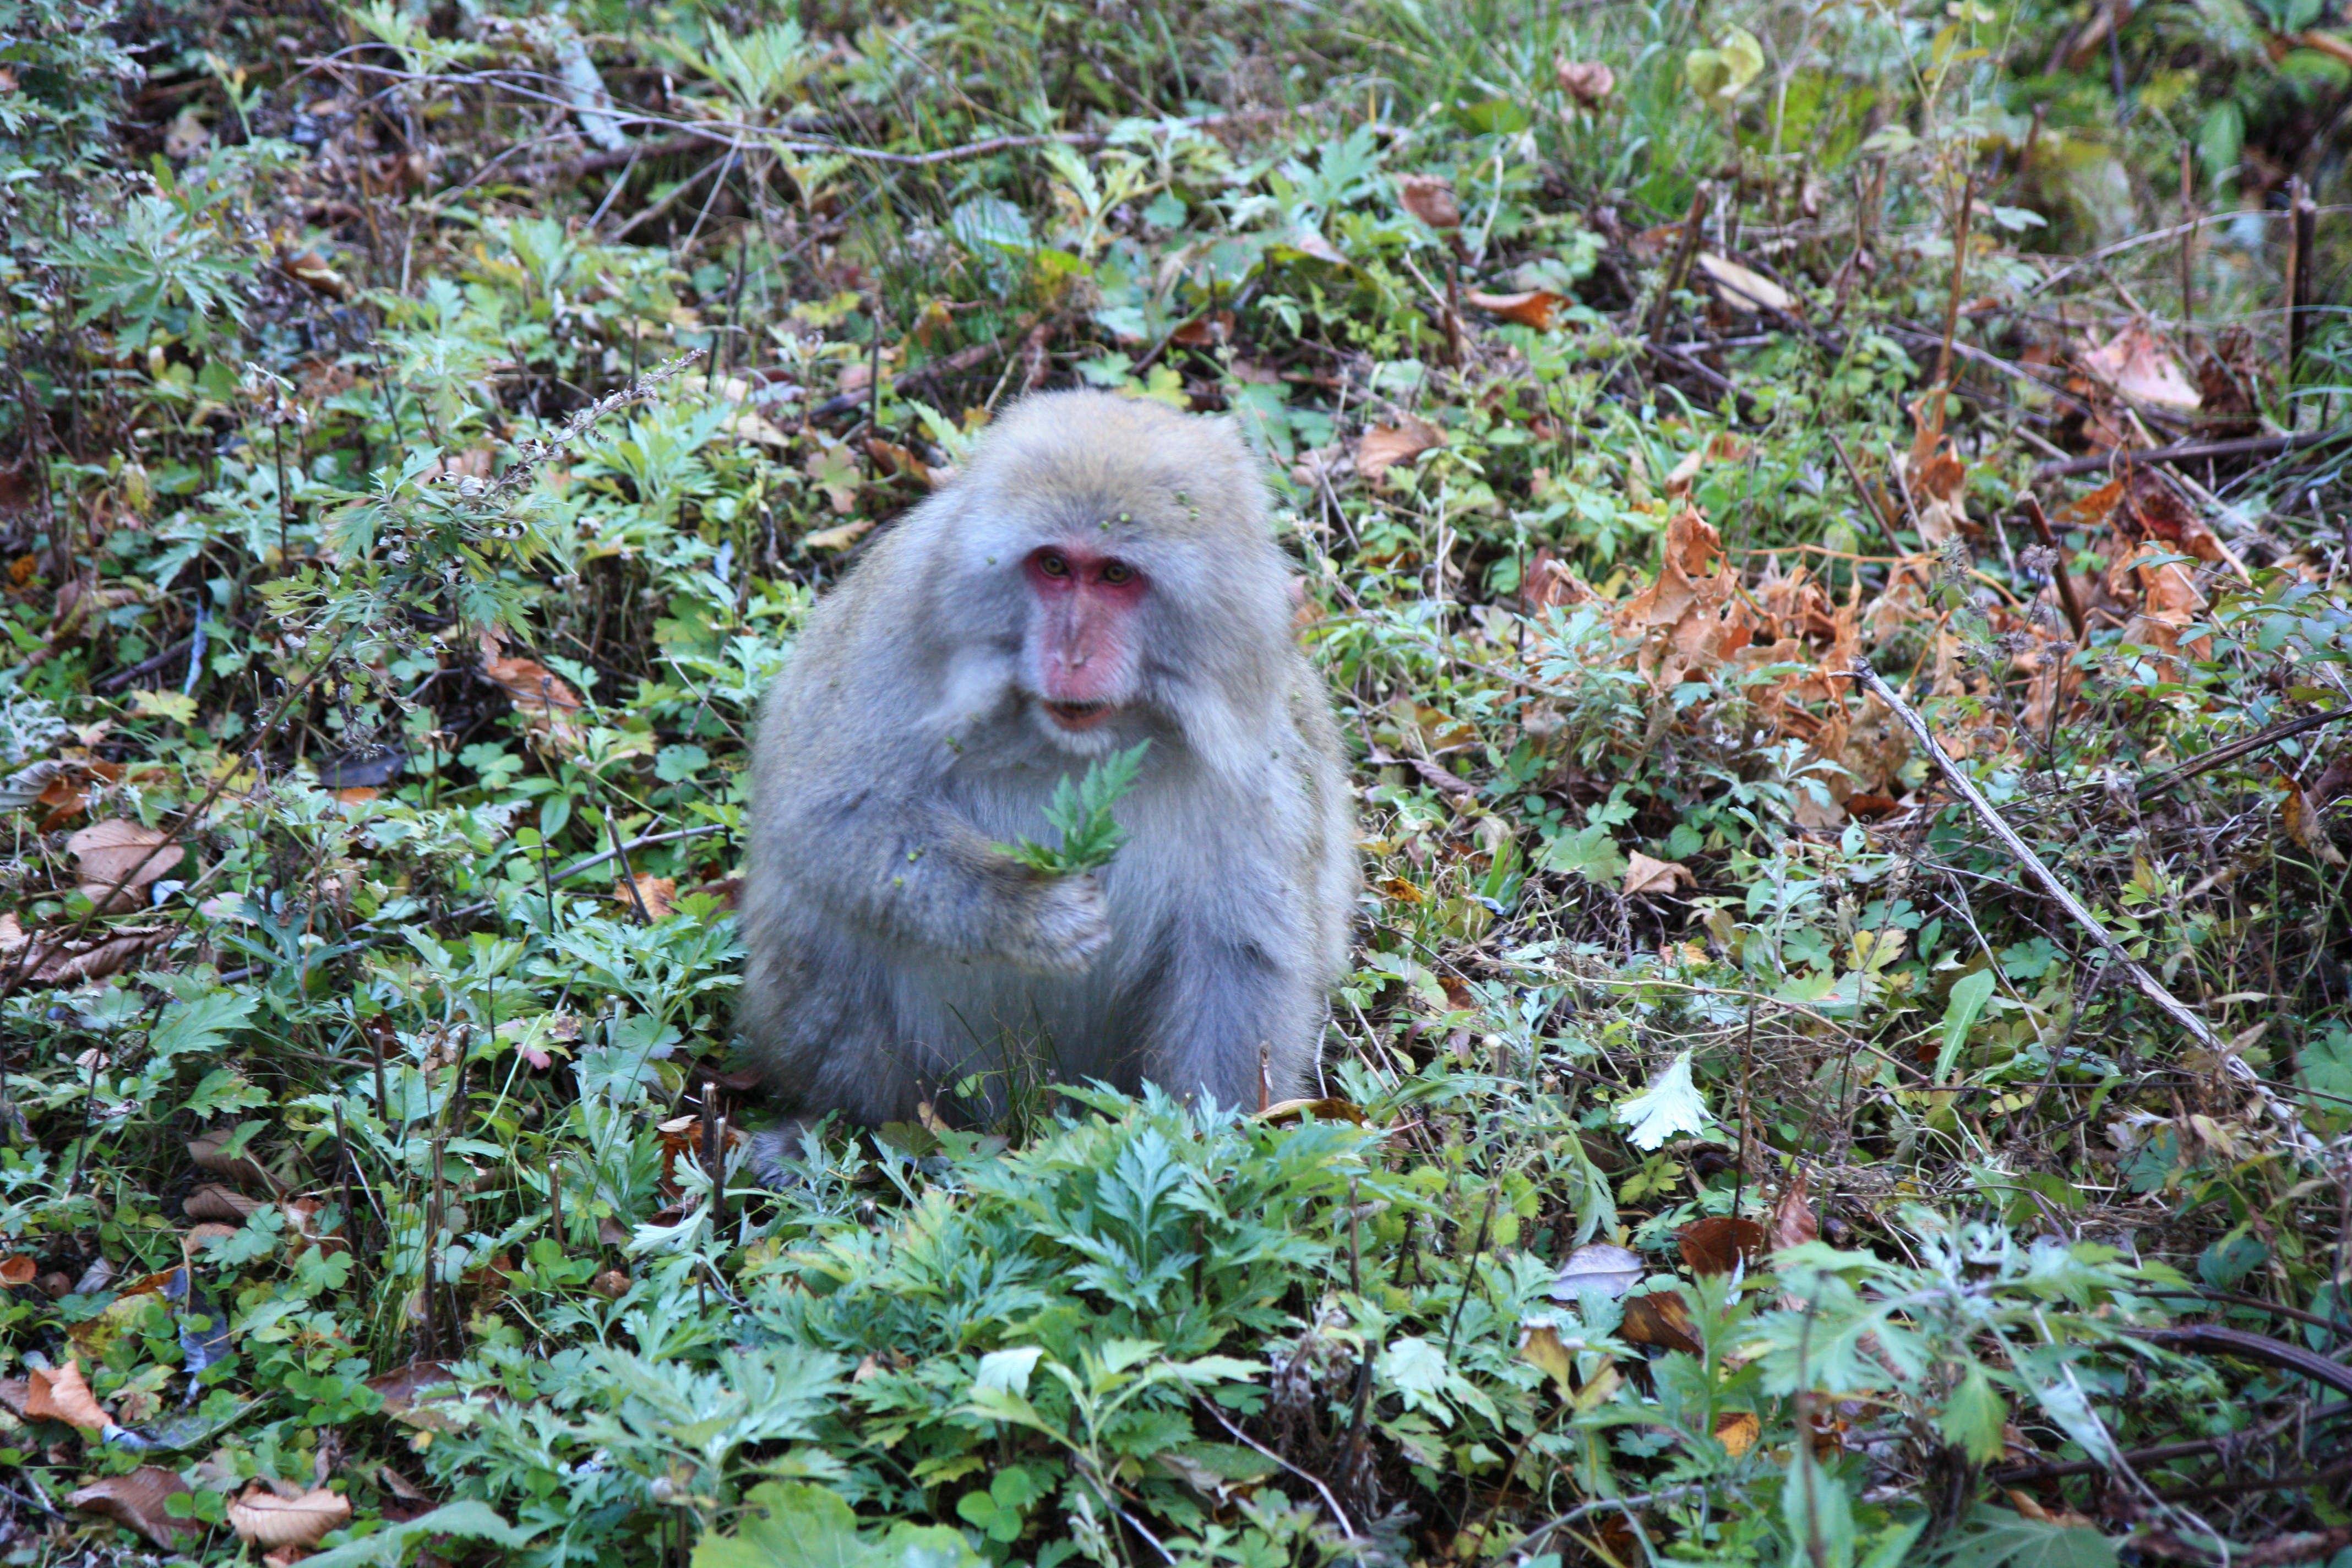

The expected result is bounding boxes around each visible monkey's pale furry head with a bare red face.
[943,393,1291,757]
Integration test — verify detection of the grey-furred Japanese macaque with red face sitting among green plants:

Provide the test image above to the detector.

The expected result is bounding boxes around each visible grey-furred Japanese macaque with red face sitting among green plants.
[736,393,1357,1168]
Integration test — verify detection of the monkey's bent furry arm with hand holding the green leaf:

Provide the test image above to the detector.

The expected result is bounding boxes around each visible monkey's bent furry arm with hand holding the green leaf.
[776,785,1110,973]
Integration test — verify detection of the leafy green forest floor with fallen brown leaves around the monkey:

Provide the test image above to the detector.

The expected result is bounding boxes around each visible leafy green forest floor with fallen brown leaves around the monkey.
[0,0,2352,1568]
